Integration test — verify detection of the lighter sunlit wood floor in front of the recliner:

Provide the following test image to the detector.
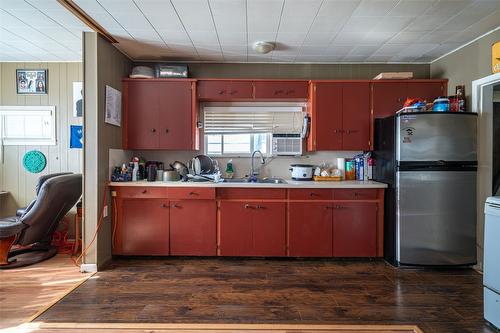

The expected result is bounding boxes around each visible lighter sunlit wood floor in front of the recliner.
[0,255,90,329]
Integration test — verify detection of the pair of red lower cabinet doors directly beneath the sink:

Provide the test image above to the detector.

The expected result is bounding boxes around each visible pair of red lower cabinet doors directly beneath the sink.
[219,200,286,256]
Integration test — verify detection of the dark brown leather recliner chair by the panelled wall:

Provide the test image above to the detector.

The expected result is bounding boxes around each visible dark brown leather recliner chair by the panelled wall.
[0,173,82,269]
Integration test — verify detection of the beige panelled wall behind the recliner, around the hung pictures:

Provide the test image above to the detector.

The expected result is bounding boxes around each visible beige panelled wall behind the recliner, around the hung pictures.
[0,62,83,216]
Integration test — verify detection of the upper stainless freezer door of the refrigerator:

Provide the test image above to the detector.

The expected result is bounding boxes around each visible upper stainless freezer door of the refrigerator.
[396,112,477,162]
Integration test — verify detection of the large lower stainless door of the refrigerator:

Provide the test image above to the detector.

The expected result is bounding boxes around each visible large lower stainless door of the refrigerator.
[396,171,476,265]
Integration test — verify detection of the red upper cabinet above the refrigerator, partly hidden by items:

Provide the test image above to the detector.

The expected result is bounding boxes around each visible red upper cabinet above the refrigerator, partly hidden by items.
[372,80,448,118]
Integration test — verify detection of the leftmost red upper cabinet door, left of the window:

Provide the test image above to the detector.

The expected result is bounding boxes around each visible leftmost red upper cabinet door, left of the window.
[124,82,158,149]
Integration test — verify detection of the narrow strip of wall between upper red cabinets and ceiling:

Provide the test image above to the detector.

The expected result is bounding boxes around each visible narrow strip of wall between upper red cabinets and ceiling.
[137,63,430,80]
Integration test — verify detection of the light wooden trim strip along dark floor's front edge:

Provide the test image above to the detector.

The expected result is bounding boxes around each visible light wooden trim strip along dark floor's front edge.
[27,322,423,333]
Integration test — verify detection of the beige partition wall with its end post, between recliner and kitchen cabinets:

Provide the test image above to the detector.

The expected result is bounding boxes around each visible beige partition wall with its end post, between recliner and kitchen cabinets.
[84,32,131,267]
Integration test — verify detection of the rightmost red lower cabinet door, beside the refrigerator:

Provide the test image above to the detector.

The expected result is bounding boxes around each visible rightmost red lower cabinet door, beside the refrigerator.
[333,202,377,257]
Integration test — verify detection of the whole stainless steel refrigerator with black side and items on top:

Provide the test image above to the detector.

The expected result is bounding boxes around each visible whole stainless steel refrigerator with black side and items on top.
[373,112,477,266]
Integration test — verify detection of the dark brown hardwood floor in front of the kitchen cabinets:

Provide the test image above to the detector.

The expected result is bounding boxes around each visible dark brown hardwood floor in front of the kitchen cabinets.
[35,258,494,333]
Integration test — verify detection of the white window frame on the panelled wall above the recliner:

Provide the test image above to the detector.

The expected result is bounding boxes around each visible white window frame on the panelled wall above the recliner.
[0,105,57,146]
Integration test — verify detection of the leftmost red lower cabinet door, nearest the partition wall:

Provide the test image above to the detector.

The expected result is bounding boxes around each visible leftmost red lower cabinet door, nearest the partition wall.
[120,199,169,256]
